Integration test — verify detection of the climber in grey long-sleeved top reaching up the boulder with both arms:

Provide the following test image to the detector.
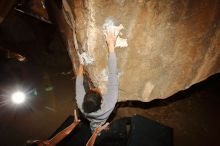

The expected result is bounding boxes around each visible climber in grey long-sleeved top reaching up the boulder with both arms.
[76,24,122,132]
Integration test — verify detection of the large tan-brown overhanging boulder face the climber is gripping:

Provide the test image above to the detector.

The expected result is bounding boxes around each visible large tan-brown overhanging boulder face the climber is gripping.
[52,0,220,102]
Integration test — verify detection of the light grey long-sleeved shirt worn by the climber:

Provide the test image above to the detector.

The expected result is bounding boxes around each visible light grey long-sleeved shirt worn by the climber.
[76,53,118,131]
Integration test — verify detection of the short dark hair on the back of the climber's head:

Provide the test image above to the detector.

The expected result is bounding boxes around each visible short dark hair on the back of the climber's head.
[82,90,102,113]
